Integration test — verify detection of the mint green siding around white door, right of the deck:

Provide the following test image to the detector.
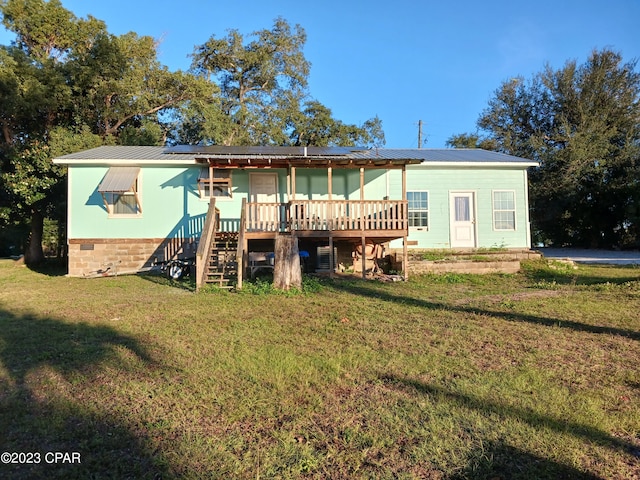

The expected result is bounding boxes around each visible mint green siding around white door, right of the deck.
[389,166,530,249]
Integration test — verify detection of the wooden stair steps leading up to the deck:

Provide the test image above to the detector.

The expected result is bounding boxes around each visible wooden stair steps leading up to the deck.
[205,232,238,290]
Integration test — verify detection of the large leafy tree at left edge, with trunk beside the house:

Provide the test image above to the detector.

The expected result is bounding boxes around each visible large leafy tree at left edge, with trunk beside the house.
[0,0,215,264]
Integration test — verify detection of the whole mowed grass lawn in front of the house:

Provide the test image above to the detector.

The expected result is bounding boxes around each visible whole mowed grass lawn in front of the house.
[0,260,640,479]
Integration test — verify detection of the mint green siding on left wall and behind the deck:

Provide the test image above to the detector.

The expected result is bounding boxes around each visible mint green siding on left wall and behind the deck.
[68,165,386,239]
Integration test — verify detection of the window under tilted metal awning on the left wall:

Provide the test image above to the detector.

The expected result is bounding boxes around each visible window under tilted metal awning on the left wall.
[98,167,142,216]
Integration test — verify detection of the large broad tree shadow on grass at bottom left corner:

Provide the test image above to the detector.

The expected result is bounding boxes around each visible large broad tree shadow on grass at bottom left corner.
[0,309,167,479]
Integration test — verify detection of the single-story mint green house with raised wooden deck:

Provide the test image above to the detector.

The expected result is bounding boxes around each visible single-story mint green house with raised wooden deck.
[53,146,537,282]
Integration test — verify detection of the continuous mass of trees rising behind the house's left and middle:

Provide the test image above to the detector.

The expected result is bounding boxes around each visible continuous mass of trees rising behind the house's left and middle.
[0,0,384,262]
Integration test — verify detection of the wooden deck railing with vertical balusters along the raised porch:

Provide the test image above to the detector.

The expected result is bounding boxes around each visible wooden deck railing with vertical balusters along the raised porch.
[245,200,409,232]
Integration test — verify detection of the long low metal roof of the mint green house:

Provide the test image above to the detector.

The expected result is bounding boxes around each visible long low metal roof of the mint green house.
[53,145,537,167]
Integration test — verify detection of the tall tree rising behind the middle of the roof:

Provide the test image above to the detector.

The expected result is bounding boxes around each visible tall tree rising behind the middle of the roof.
[188,18,384,146]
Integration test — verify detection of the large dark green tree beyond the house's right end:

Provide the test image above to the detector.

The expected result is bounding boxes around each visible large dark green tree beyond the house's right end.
[450,50,640,247]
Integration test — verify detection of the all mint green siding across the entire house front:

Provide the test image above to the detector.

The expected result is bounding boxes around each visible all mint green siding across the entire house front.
[68,165,530,248]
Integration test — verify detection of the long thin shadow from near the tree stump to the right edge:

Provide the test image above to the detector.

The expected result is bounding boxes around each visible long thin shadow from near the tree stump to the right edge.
[332,280,640,341]
